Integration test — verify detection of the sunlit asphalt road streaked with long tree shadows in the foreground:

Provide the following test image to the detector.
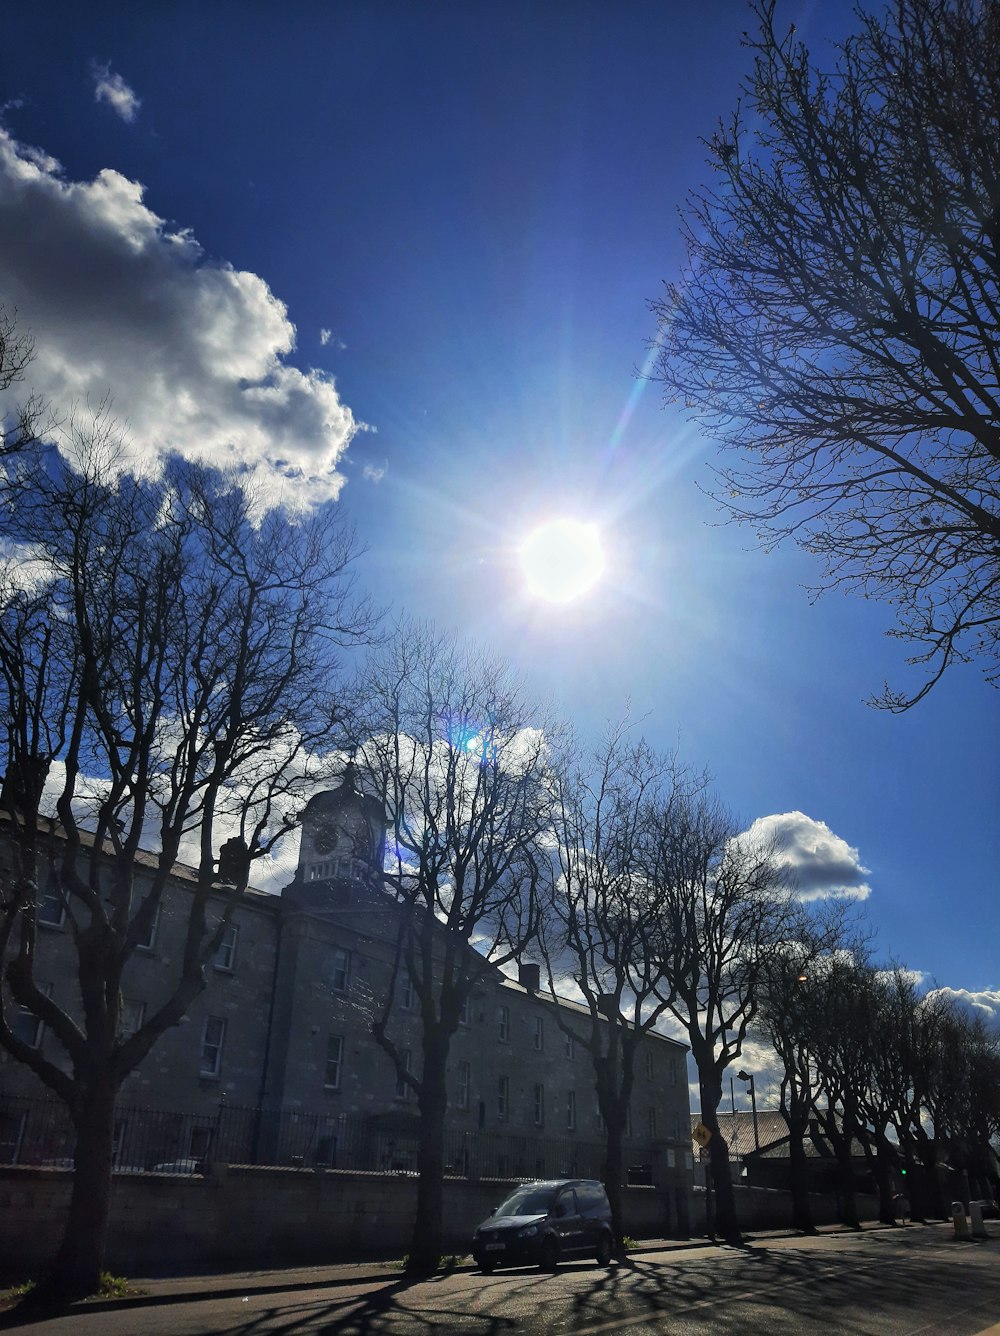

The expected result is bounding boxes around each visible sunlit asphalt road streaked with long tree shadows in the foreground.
[8,1226,1000,1336]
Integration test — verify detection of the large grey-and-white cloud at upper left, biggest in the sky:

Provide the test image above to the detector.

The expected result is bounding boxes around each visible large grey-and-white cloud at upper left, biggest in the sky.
[0,130,358,510]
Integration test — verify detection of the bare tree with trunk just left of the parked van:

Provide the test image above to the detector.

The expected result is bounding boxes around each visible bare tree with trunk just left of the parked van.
[356,623,554,1275]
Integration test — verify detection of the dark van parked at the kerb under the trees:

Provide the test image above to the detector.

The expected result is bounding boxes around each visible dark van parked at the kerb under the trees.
[473,1178,614,1272]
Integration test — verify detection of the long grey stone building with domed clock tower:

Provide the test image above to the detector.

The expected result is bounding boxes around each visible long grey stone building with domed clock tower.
[0,774,692,1186]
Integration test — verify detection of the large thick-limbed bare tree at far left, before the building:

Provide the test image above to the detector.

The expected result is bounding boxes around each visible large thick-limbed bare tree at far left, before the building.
[0,421,367,1297]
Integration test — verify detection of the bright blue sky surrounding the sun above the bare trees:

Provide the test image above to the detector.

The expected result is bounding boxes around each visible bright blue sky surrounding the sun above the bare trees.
[0,0,1000,1031]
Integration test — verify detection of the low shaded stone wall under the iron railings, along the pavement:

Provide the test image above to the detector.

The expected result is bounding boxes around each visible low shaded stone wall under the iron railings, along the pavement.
[0,1165,690,1277]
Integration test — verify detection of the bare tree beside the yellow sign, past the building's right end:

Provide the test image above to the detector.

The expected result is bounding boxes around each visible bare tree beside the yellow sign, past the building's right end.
[649,792,797,1240]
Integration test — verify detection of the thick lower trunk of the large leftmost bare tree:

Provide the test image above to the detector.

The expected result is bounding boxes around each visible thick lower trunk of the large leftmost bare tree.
[41,1075,117,1303]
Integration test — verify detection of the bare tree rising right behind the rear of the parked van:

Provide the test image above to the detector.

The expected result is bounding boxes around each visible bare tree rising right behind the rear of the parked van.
[545,724,692,1246]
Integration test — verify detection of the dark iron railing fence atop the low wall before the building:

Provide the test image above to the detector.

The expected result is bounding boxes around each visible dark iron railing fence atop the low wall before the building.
[0,1097,605,1178]
